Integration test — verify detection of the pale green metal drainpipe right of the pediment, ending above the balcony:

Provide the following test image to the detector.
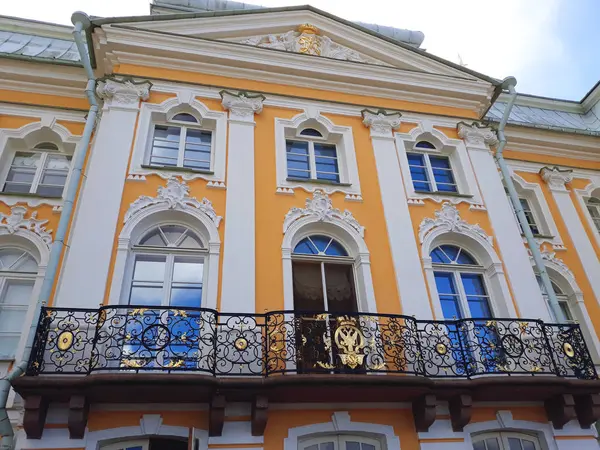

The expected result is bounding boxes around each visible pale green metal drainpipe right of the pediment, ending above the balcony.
[494,77,566,322]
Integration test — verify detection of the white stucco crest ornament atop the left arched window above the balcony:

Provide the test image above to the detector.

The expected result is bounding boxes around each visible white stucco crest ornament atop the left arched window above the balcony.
[124,178,222,227]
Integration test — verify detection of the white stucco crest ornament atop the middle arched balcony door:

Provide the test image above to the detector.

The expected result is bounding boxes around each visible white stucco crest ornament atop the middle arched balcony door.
[283,190,365,237]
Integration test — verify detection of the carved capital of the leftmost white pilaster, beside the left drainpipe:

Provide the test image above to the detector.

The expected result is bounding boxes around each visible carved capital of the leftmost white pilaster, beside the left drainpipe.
[96,77,152,109]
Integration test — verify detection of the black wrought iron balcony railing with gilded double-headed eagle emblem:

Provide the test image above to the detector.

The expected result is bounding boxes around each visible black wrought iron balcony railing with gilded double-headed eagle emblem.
[28,306,597,379]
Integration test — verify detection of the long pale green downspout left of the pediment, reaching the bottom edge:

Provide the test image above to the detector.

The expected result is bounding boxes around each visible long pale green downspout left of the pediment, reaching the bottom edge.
[0,12,98,450]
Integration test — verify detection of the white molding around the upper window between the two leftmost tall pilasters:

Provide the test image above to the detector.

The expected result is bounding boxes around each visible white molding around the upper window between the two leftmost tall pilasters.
[129,89,227,183]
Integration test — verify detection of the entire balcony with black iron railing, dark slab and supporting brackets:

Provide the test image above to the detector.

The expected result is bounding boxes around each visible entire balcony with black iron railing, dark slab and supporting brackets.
[13,306,600,439]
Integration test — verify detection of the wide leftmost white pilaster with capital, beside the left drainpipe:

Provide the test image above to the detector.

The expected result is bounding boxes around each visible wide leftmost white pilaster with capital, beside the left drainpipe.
[56,78,152,308]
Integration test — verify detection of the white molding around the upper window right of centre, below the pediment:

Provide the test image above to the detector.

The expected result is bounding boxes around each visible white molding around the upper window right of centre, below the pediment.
[395,116,483,205]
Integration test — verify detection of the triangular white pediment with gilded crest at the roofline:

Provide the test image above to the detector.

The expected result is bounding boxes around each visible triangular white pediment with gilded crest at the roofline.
[108,6,489,81]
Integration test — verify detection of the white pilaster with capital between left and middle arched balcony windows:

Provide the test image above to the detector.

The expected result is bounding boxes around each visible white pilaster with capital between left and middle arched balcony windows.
[221,91,265,313]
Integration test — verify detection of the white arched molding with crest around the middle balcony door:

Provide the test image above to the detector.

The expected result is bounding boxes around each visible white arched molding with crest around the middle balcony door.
[281,191,377,313]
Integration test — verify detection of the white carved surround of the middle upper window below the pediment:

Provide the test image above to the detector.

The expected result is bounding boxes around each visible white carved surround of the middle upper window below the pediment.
[275,108,362,201]
